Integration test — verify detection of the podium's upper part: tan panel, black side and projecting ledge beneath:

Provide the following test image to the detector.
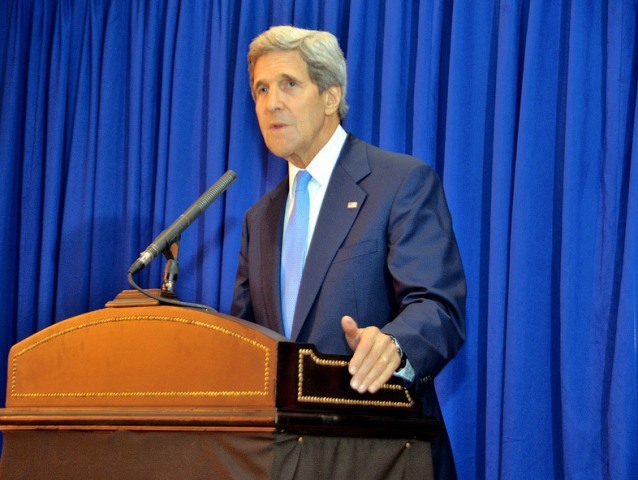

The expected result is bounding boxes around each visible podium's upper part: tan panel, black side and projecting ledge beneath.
[0,305,440,438]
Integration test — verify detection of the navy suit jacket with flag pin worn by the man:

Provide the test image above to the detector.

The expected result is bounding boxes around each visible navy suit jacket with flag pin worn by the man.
[230,135,466,402]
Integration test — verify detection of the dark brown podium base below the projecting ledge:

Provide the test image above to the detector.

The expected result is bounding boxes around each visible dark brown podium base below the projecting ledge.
[0,430,433,480]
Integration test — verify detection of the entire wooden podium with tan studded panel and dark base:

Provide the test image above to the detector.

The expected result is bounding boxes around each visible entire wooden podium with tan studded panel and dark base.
[0,306,440,480]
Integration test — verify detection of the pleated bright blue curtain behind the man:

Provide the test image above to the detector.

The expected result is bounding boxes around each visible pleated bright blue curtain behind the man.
[0,0,638,480]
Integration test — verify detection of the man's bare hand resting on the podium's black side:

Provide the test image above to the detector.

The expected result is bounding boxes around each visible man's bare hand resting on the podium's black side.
[348,327,401,393]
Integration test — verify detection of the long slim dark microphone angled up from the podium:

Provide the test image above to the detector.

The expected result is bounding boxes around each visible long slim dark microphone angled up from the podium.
[128,170,237,275]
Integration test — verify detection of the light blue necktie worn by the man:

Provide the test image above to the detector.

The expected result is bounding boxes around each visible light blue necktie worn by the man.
[281,170,312,338]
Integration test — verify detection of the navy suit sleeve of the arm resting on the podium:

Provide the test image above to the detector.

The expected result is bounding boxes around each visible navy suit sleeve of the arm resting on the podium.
[383,164,466,392]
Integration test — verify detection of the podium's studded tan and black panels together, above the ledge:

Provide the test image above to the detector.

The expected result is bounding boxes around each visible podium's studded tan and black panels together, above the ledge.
[6,305,420,413]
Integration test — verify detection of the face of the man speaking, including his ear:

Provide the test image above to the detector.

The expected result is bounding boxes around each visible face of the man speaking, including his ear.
[253,50,341,168]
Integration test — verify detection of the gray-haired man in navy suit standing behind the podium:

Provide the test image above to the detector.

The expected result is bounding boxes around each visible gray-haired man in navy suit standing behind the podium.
[231,27,466,480]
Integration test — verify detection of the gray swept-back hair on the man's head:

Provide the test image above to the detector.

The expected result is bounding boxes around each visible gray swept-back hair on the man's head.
[248,25,348,118]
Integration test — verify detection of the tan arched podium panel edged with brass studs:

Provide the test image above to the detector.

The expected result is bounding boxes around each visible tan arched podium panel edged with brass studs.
[6,306,281,408]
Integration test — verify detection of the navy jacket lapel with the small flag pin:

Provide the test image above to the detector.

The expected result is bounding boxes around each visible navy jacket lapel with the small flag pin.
[290,135,370,341]
